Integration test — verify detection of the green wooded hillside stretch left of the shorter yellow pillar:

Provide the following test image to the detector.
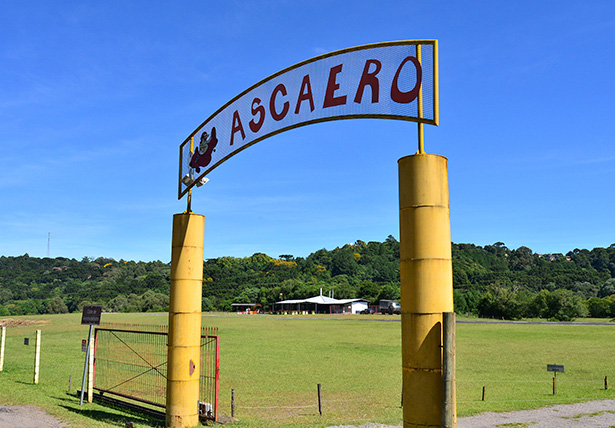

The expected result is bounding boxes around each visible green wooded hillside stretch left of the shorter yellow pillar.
[0,254,170,316]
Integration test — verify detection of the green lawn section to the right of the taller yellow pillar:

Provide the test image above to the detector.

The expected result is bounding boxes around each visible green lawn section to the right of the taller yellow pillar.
[457,324,615,415]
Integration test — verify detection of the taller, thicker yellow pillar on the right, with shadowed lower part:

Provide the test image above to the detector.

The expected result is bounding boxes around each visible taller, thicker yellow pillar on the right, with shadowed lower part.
[398,153,453,428]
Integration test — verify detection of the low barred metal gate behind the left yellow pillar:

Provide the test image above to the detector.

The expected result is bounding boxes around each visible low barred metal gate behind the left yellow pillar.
[94,323,220,421]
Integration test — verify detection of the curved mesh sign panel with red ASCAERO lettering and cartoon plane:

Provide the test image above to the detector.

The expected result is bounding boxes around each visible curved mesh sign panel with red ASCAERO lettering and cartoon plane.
[179,40,438,198]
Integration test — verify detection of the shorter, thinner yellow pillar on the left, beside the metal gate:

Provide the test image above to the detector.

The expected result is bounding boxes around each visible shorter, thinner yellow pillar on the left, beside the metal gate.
[166,213,205,428]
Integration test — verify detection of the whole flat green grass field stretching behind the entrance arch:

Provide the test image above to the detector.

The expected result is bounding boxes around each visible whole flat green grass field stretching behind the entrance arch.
[0,314,615,427]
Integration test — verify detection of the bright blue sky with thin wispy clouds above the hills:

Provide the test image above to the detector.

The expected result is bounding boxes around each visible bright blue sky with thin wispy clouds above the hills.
[0,0,615,262]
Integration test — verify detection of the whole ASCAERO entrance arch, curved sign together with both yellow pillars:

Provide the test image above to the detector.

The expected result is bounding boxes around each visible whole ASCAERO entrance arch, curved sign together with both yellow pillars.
[167,40,456,428]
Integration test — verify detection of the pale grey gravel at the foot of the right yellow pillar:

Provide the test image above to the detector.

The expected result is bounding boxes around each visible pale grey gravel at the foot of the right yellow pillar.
[329,400,615,428]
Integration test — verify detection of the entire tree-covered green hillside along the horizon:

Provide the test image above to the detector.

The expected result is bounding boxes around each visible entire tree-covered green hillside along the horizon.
[0,236,615,320]
